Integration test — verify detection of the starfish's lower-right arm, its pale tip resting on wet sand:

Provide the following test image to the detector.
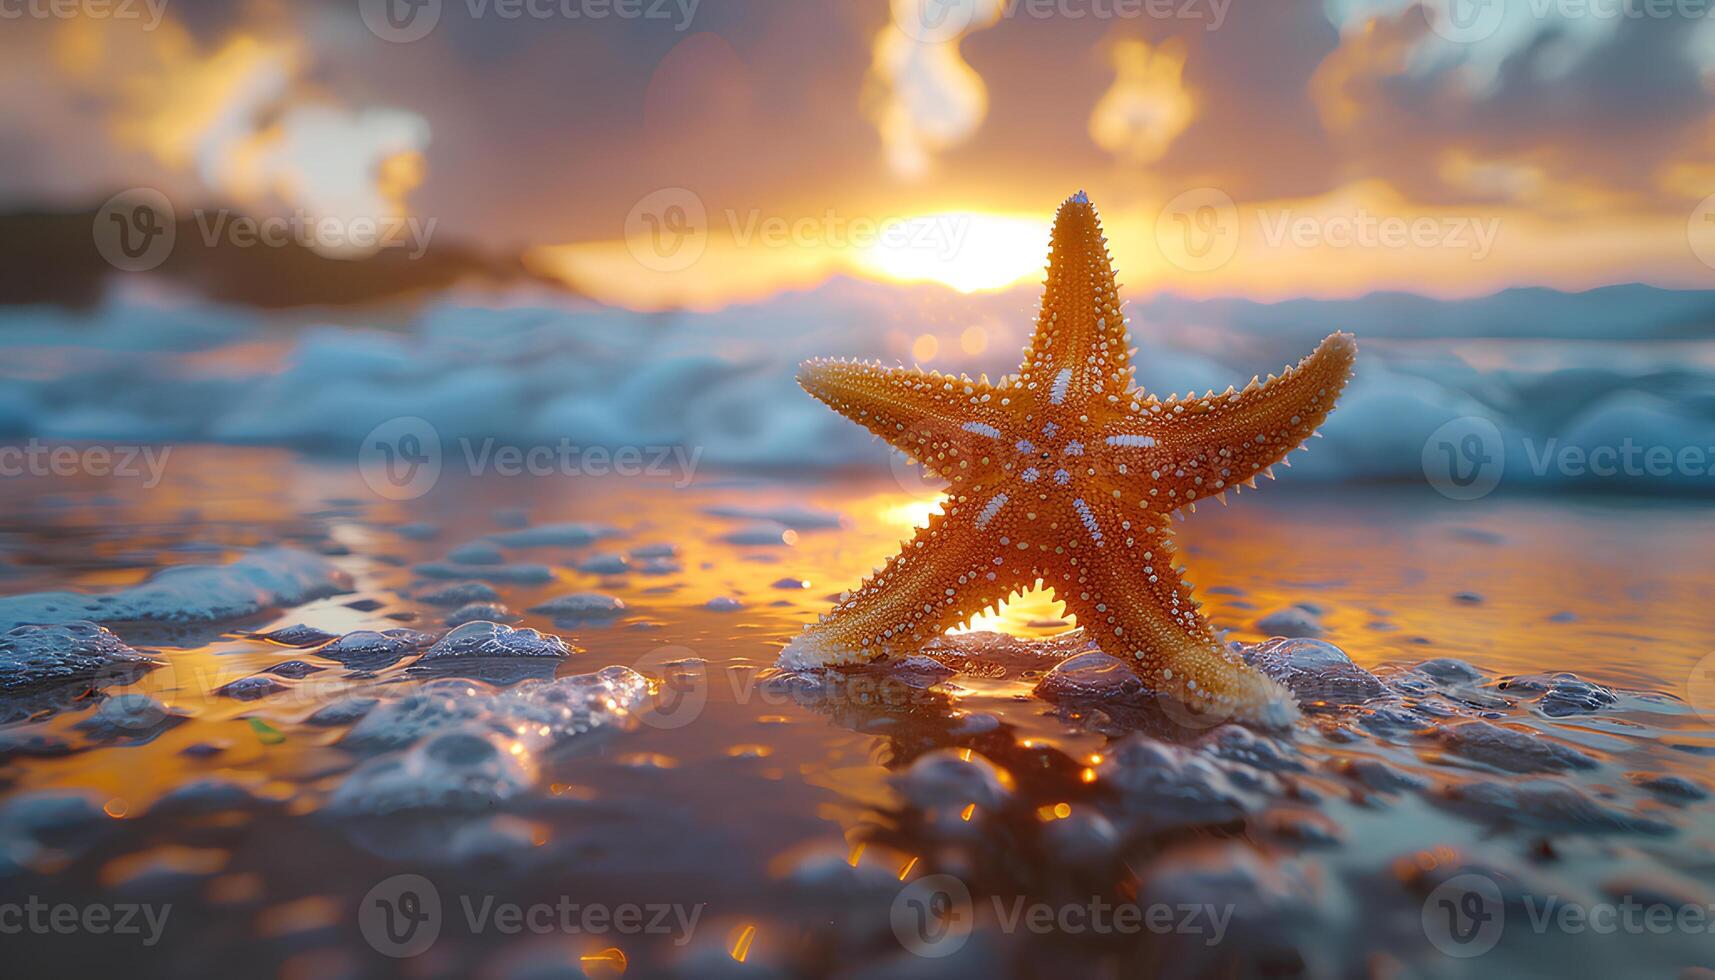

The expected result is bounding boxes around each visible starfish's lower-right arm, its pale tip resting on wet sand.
[1050,503,1298,728]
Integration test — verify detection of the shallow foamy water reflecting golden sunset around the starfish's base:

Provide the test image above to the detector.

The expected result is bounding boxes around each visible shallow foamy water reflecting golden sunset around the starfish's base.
[0,448,1715,977]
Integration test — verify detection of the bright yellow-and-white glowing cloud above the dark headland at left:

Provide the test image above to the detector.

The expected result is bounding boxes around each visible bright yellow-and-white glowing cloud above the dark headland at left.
[8,5,429,254]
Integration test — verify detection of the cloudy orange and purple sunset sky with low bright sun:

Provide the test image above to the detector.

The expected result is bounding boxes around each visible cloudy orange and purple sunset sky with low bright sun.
[0,0,1715,309]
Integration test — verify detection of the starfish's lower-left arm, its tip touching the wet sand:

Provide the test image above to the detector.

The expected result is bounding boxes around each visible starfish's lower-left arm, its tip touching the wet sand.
[780,496,1036,668]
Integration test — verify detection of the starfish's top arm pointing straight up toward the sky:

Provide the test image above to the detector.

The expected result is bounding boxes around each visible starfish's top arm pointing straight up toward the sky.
[1019,192,1132,398]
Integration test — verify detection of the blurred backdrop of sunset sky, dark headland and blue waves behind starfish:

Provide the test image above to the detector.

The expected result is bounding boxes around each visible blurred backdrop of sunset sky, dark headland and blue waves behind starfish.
[0,0,1715,494]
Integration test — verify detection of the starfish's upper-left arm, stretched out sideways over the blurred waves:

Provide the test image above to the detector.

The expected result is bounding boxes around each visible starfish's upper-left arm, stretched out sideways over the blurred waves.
[797,359,1008,481]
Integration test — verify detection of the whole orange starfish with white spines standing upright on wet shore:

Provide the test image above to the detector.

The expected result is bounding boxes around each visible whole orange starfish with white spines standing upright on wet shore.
[780,191,1357,726]
